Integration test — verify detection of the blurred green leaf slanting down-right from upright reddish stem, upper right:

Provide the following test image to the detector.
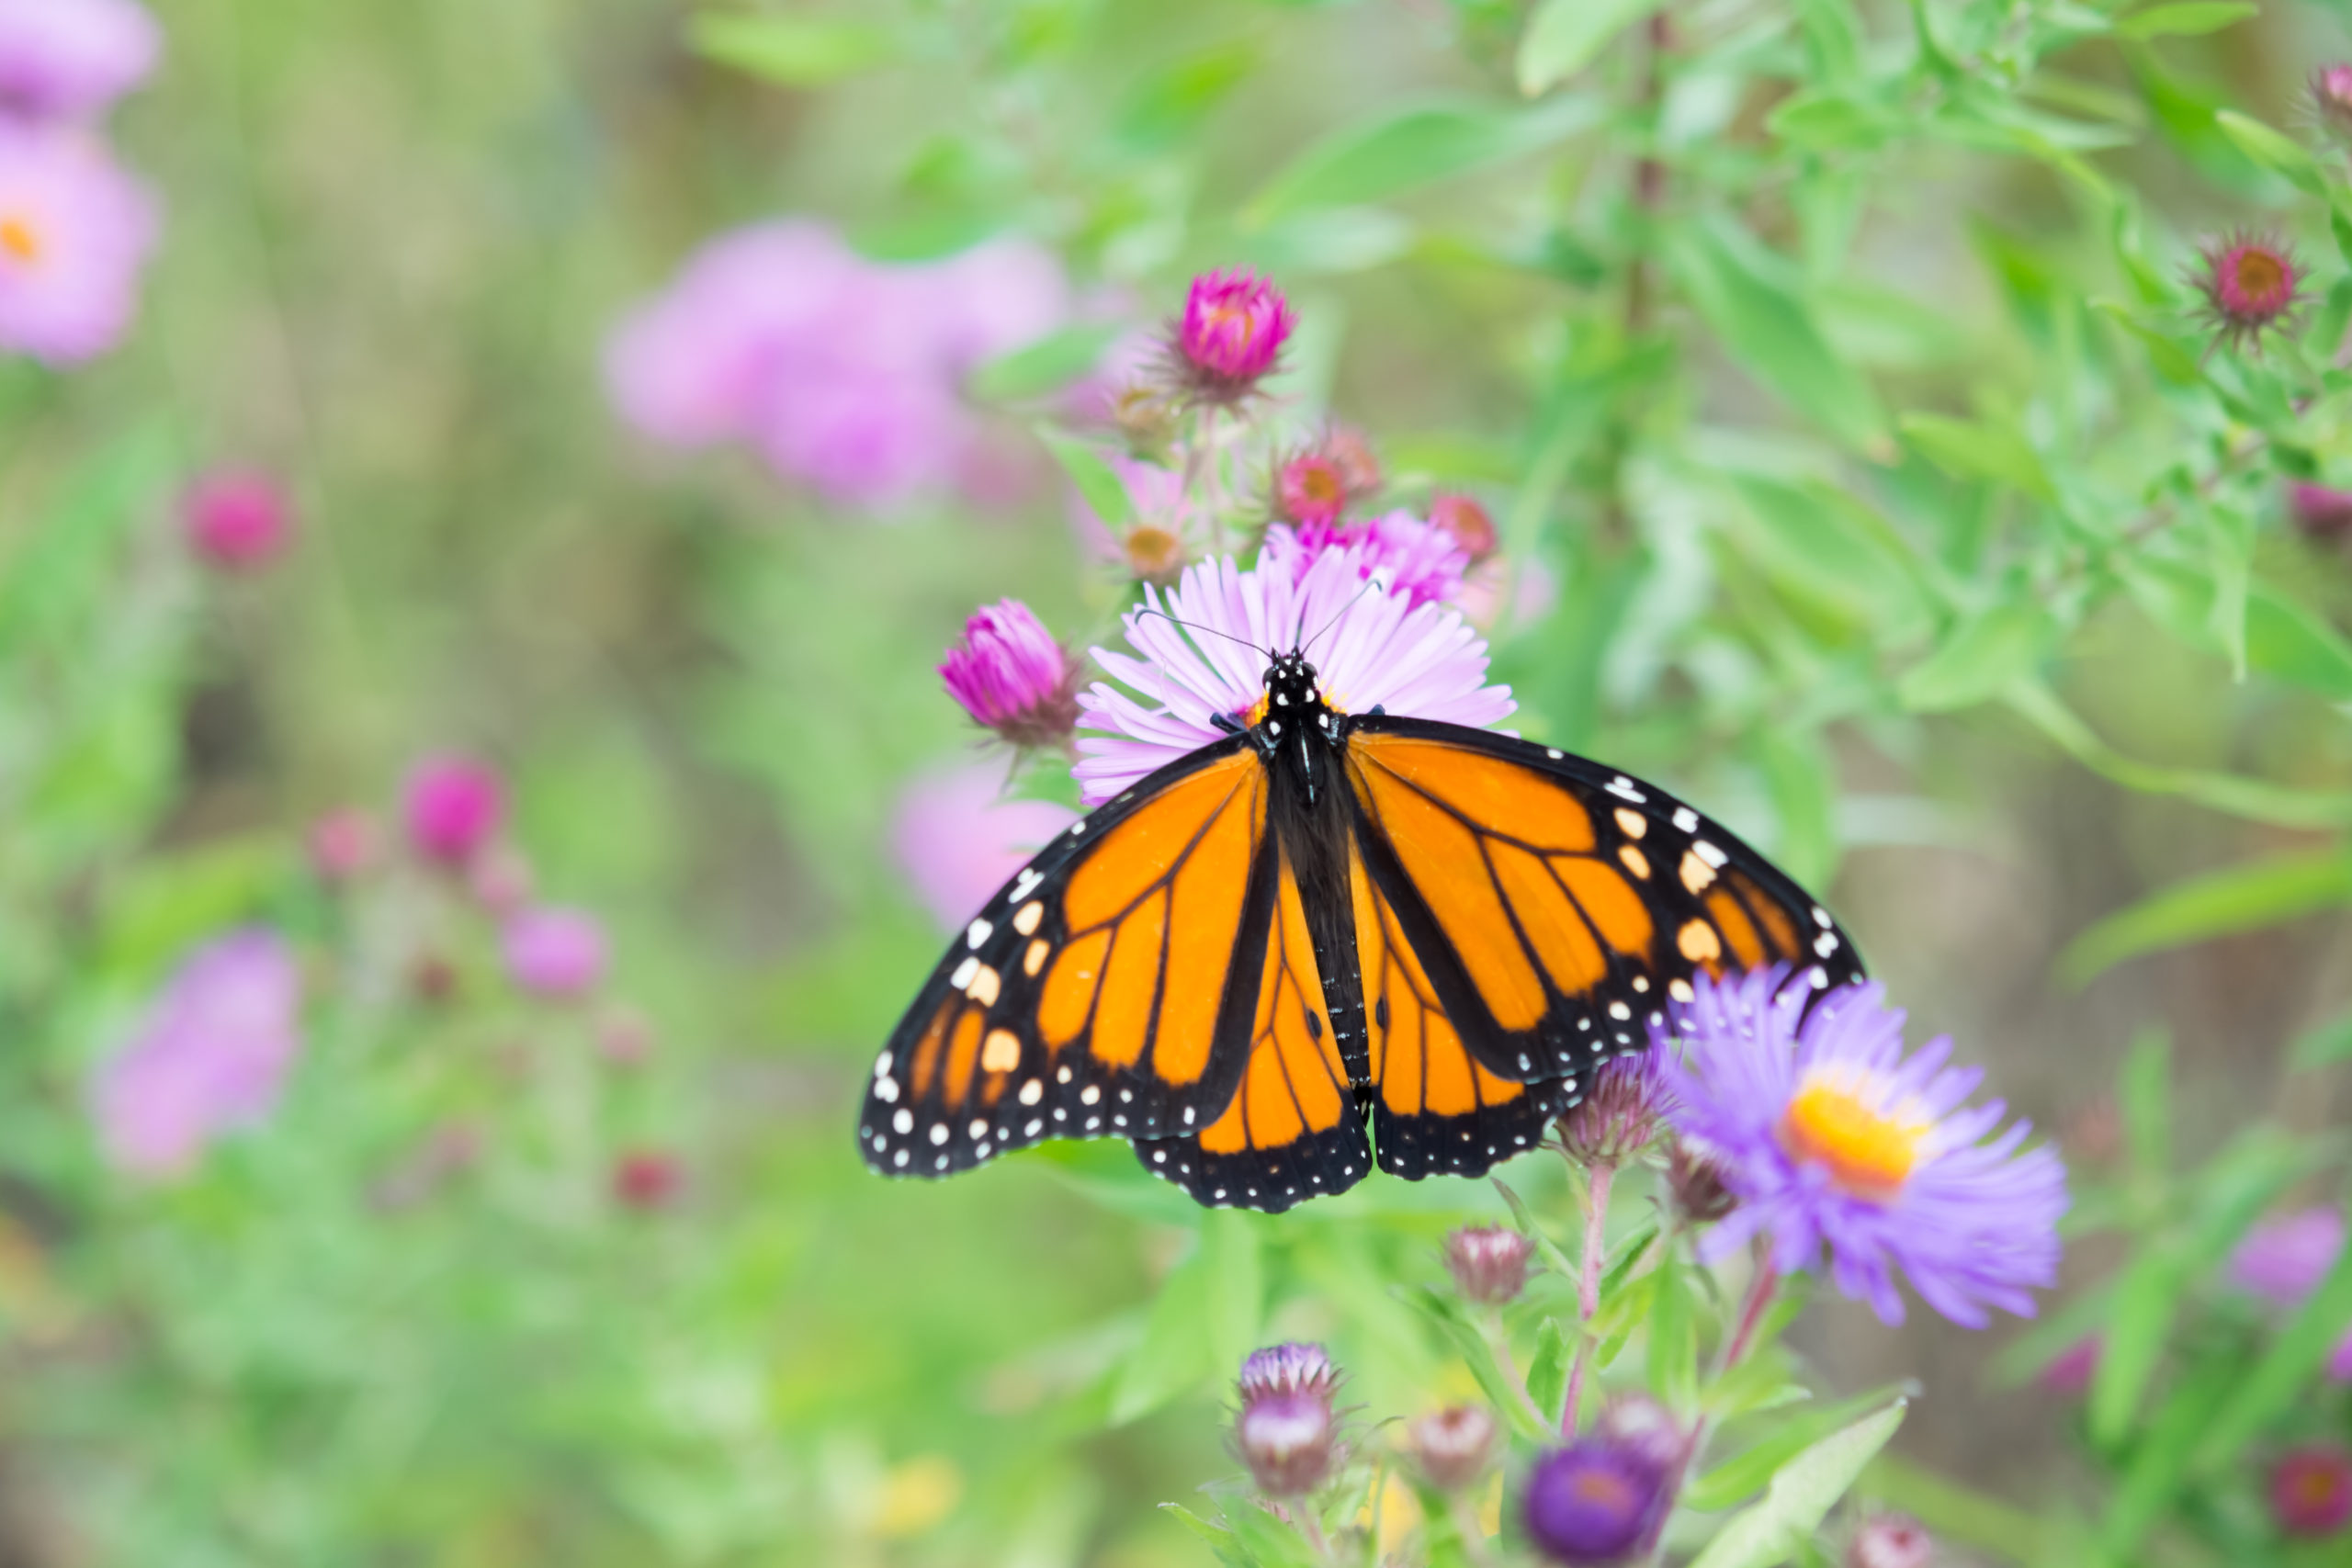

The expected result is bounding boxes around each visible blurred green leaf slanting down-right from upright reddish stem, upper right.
[1665,216,1886,449]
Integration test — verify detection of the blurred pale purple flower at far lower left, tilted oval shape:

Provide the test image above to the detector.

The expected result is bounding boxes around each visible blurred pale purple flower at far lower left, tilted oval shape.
[94,926,301,1176]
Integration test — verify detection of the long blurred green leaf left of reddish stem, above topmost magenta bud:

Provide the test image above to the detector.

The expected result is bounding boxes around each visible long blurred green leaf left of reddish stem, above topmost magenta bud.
[1247,94,1606,226]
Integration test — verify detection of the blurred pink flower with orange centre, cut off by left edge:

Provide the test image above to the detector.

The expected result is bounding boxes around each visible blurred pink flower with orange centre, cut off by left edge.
[0,122,155,365]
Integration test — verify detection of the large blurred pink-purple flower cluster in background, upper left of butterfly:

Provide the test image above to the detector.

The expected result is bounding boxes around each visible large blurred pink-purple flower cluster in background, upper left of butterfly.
[605,219,1070,510]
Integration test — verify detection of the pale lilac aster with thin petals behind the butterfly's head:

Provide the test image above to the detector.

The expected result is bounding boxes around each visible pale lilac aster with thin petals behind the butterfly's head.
[1072,550,1512,807]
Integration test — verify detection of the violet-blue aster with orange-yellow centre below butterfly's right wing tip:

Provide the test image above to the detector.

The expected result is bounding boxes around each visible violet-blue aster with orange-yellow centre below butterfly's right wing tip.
[1654,966,2067,1328]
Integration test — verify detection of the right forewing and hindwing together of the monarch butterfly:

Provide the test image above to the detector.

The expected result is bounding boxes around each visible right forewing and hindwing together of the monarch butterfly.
[1348,715,1863,1176]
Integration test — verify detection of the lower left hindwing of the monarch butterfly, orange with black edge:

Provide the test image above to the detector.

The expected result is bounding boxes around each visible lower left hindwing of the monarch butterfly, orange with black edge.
[1136,835,1371,1213]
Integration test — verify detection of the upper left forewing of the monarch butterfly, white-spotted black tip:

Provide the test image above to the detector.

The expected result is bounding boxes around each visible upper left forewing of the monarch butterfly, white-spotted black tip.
[858,739,1275,1176]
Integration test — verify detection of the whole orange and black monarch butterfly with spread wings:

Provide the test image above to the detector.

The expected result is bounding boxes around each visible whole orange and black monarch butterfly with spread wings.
[858,647,1863,1213]
